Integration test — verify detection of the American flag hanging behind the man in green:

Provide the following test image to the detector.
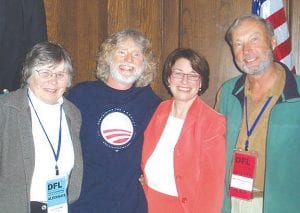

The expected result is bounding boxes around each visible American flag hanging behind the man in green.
[252,0,296,74]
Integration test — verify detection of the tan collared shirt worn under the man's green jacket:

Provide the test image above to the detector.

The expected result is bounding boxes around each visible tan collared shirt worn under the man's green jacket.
[236,70,285,191]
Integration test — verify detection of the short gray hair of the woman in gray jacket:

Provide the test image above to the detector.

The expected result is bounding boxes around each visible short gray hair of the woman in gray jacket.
[21,41,74,87]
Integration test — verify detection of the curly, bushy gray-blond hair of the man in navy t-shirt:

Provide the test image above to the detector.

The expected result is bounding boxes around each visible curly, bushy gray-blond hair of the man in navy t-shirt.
[96,29,156,87]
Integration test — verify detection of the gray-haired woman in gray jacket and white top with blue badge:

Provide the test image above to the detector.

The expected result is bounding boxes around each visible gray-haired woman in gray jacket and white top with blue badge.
[0,42,82,213]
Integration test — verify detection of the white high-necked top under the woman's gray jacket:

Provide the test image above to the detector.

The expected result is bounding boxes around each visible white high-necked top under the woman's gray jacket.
[28,89,74,202]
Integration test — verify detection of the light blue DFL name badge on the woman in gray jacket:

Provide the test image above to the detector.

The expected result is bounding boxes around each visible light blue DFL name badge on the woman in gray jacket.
[47,176,68,213]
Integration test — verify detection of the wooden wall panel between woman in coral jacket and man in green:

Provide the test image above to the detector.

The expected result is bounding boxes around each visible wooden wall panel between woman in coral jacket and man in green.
[181,0,251,105]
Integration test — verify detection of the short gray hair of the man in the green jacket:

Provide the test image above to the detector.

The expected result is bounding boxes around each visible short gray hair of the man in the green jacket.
[225,14,274,46]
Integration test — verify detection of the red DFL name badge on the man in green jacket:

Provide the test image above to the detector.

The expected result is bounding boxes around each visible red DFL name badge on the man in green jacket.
[229,151,257,200]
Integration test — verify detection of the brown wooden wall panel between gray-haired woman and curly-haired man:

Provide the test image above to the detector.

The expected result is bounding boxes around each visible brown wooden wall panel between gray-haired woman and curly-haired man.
[44,0,107,83]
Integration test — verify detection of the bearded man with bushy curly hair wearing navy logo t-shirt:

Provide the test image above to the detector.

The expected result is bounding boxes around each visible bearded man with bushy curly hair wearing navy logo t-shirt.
[68,30,160,213]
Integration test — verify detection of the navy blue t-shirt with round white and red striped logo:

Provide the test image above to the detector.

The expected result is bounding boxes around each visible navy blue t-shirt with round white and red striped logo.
[67,81,160,213]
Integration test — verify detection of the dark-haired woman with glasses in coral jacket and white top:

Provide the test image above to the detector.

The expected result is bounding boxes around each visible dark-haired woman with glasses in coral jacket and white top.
[141,48,225,213]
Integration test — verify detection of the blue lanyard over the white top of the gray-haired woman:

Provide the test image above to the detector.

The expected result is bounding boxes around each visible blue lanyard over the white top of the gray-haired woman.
[27,93,62,175]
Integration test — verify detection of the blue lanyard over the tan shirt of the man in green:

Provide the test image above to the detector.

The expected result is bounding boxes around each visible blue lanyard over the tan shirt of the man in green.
[245,96,272,151]
